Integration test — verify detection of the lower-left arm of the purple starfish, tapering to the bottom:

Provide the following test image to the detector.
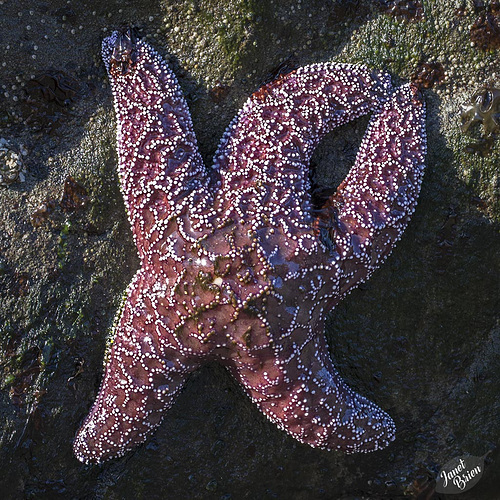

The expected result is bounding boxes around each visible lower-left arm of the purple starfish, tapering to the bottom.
[73,272,198,463]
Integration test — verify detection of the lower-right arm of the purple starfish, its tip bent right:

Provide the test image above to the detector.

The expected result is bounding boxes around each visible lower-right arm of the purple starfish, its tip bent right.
[233,325,396,453]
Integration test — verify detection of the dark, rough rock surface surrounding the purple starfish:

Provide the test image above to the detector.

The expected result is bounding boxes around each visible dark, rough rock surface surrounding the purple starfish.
[0,0,500,500]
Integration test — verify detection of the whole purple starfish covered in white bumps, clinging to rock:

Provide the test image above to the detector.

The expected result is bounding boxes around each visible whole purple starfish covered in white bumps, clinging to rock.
[74,30,426,463]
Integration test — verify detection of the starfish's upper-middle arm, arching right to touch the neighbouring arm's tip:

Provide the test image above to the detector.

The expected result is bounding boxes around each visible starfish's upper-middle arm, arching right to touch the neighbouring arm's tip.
[211,63,390,226]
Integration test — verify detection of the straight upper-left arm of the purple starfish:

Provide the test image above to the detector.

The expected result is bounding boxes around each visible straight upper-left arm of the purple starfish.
[102,30,210,257]
